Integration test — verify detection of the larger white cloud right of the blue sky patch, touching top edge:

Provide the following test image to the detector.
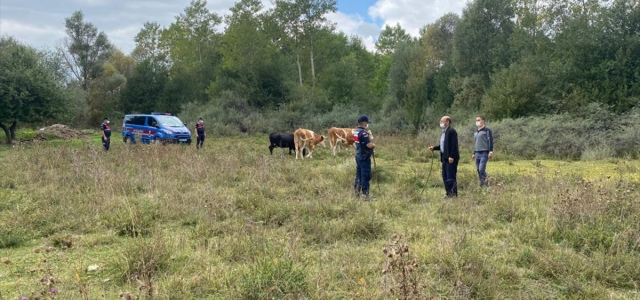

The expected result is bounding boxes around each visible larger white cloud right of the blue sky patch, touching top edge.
[369,0,466,36]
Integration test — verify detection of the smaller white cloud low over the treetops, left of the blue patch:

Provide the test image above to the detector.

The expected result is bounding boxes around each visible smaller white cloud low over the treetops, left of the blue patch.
[327,12,380,51]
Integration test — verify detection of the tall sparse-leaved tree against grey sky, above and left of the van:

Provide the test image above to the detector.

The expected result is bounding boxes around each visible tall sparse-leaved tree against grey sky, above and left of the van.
[63,11,113,91]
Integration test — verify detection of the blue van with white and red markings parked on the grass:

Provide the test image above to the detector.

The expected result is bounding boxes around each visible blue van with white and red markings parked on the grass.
[122,113,191,144]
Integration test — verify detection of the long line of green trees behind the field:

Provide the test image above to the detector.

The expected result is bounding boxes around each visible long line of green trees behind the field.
[0,0,640,140]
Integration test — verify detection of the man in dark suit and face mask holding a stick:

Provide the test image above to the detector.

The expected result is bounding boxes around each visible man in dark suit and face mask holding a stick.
[429,116,460,198]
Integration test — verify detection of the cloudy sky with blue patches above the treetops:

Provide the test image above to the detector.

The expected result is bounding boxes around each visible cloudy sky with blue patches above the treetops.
[0,0,467,53]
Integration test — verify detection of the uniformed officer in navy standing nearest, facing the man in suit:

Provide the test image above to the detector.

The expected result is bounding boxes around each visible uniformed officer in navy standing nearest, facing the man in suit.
[353,115,376,201]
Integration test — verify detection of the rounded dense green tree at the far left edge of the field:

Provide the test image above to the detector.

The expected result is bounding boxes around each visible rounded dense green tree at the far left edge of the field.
[0,37,64,144]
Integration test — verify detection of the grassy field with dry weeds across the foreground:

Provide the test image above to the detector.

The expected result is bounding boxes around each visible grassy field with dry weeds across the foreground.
[0,136,640,299]
